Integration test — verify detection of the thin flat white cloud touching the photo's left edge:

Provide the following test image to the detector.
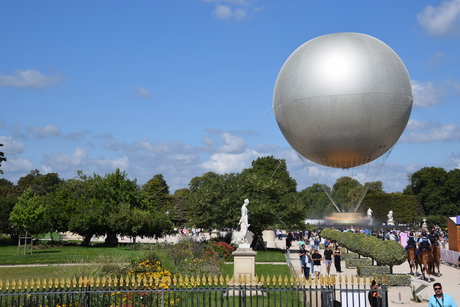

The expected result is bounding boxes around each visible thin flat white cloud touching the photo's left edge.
[0,69,65,88]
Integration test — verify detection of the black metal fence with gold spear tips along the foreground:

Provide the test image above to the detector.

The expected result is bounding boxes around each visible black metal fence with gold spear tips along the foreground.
[0,276,388,307]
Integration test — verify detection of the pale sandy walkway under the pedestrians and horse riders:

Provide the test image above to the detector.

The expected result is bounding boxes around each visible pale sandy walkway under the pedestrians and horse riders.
[275,239,460,307]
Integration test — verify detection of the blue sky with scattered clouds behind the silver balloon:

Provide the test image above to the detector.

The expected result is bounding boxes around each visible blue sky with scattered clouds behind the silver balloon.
[0,0,460,192]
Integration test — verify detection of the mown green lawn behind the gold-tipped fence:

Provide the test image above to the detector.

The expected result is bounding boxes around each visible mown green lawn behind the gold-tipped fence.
[0,245,291,281]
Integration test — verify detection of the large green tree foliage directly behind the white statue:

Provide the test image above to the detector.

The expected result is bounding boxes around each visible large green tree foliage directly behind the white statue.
[185,159,305,234]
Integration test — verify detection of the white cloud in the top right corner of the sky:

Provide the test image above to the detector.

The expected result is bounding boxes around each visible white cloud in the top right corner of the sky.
[417,0,460,36]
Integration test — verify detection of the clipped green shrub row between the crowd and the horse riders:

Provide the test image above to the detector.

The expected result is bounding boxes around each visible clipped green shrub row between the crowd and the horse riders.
[321,229,406,272]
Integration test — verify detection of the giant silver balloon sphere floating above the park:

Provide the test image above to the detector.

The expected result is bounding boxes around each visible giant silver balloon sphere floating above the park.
[273,33,413,168]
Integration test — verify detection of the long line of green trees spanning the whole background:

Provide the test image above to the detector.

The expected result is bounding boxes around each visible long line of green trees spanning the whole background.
[0,156,460,244]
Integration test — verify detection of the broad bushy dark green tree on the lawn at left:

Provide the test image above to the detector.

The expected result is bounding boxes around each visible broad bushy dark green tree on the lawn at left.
[48,169,170,245]
